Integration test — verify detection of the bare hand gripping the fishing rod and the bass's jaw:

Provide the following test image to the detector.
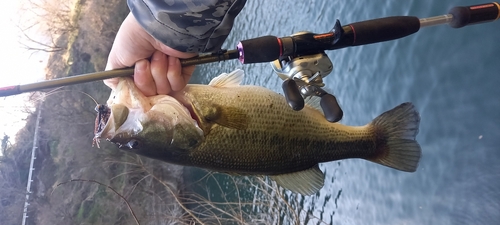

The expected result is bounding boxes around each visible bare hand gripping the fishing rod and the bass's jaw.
[104,13,196,96]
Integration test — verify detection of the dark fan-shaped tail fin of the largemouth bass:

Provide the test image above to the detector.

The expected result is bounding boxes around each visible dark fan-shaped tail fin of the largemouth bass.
[368,102,422,172]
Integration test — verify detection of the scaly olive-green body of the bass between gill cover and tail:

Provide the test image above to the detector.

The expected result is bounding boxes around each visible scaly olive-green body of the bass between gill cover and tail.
[184,85,375,174]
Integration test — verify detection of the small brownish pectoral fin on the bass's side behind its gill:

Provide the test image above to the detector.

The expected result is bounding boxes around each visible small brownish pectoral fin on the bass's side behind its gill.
[204,105,248,130]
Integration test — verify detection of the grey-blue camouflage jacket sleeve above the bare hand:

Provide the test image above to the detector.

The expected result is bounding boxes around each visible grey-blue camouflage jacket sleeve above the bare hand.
[127,0,246,52]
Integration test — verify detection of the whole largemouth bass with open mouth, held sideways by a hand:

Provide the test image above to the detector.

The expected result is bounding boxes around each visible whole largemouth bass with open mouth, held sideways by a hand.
[96,70,421,195]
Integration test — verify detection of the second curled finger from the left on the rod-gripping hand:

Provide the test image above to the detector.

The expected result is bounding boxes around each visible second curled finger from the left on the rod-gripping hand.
[151,51,172,95]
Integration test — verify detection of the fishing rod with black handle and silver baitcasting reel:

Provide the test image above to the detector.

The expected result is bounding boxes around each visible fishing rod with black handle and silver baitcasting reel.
[0,2,500,122]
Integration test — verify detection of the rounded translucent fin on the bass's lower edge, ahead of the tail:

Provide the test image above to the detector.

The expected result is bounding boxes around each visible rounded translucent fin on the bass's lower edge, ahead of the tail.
[269,164,325,195]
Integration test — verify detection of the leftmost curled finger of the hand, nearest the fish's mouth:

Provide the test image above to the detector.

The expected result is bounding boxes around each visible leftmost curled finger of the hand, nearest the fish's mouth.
[134,59,156,96]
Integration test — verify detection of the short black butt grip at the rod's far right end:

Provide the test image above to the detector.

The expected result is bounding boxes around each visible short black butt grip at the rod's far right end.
[449,2,500,28]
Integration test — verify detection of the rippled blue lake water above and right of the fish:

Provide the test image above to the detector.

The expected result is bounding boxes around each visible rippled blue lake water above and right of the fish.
[189,0,500,224]
